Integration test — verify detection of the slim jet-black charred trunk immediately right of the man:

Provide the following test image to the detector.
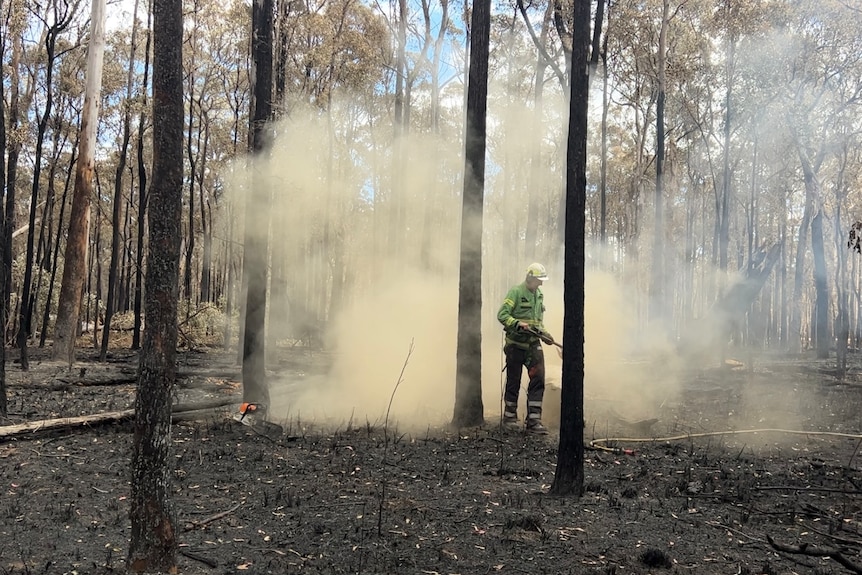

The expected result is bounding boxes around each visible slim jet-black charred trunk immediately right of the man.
[551,0,590,497]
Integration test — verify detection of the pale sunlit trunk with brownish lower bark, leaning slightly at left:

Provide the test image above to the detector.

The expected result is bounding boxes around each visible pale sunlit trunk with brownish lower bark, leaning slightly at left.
[52,0,105,365]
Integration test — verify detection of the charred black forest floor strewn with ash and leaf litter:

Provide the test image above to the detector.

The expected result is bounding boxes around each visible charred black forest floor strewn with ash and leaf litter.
[0,348,862,575]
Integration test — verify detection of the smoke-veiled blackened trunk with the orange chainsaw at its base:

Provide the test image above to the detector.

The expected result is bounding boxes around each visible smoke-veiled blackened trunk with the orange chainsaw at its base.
[242,0,274,405]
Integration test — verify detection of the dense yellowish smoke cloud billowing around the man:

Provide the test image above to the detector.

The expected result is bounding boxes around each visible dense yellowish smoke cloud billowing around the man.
[221,86,696,428]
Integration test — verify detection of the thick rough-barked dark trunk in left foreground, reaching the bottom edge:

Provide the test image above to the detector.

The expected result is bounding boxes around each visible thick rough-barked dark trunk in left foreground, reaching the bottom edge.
[127,0,183,573]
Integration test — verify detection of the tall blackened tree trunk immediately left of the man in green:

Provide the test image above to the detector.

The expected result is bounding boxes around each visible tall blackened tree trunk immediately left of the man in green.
[452,0,491,427]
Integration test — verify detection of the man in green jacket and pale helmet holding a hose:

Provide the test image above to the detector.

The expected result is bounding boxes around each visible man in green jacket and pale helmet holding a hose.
[497,263,549,435]
